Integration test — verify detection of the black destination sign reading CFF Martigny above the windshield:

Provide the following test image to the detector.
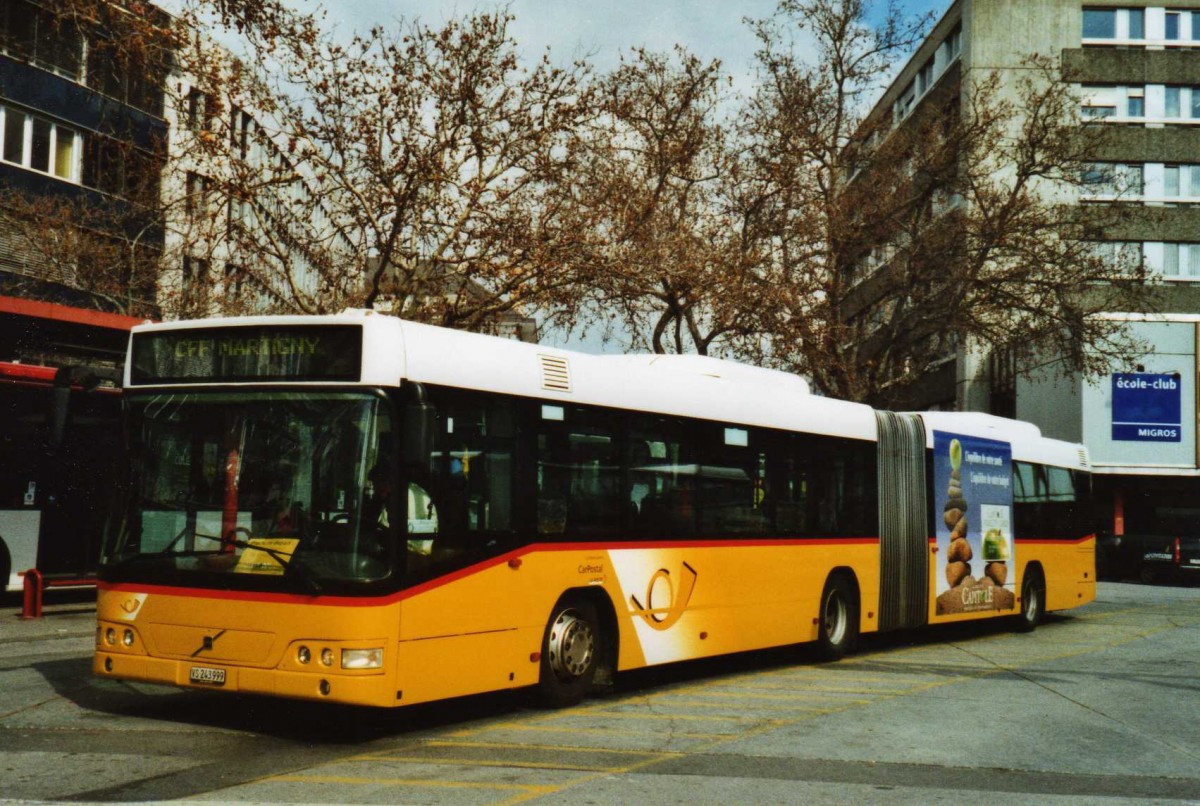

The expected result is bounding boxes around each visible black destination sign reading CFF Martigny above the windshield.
[130,325,362,384]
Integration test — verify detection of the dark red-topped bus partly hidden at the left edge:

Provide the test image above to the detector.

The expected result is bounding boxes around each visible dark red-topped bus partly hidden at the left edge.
[0,362,121,591]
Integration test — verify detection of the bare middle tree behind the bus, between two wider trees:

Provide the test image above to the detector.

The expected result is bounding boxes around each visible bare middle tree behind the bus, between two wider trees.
[566,48,761,355]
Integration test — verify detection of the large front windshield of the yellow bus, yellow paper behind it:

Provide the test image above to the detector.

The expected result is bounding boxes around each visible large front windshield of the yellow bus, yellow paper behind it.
[104,390,395,594]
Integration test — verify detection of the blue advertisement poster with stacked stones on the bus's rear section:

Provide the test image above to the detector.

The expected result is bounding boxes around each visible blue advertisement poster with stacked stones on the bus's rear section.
[934,431,1016,615]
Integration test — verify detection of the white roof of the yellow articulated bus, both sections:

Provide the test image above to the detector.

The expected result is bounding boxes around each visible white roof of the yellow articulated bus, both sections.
[126,309,1088,468]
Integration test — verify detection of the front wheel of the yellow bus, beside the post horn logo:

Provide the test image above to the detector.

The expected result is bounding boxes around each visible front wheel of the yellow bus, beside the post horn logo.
[538,596,602,708]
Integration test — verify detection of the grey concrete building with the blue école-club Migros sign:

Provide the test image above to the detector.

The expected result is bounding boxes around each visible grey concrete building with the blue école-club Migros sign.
[876,0,1200,573]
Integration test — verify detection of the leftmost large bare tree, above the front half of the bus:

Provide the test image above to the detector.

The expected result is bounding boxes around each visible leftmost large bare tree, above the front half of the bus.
[176,6,604,327]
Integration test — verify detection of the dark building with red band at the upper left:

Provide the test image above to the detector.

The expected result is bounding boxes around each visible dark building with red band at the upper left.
[0,0,167,365]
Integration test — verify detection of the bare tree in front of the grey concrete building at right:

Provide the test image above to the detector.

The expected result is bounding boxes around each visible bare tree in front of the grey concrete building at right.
[745,0,1146,405]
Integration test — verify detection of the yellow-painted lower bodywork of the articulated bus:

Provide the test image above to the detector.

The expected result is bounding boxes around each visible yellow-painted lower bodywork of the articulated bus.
[94,540,1094,706]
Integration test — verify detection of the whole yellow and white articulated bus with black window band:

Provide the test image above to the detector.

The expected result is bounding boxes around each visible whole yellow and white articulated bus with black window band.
[94,311,1096,706]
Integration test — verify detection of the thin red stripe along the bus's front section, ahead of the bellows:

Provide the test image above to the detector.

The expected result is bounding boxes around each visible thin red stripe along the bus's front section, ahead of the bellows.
[97,537,880,607]
